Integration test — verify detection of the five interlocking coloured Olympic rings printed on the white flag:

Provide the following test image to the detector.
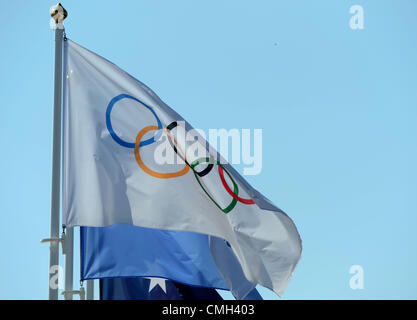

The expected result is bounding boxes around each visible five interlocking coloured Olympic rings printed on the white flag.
[106,94,255,214]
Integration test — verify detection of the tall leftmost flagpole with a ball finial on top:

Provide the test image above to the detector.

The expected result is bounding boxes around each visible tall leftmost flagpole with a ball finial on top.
[48,3,66,300]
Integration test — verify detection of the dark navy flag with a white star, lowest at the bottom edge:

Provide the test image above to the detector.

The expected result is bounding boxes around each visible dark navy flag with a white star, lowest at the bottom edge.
[100,278,223,301]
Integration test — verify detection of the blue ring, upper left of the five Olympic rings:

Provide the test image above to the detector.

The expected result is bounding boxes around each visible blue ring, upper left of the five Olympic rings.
[106,93,162,149]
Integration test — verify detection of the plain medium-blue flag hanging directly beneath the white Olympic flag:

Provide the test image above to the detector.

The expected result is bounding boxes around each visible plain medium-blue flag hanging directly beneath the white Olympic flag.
[80,225,228,290]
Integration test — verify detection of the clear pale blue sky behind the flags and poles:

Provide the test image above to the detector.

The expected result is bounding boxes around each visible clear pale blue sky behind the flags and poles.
[0,0,417,299]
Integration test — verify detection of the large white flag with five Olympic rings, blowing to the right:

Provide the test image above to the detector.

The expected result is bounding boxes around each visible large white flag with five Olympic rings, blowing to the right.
[63,39,301,296]
